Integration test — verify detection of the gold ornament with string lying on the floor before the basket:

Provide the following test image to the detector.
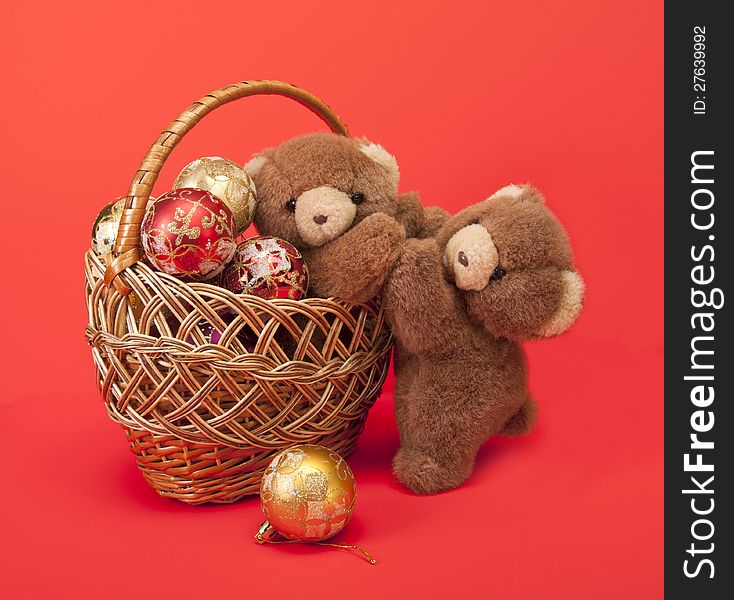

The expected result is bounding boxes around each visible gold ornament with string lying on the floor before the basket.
[255,444,376,564]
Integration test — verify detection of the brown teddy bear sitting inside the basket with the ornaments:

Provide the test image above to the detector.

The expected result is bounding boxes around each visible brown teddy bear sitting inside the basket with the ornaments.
[245,133,448,303]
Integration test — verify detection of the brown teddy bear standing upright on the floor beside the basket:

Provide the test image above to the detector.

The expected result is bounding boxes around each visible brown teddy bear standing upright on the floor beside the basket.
[383,186,584,494]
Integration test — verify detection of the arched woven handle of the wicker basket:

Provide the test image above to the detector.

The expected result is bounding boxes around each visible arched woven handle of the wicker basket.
[104,80,349,295]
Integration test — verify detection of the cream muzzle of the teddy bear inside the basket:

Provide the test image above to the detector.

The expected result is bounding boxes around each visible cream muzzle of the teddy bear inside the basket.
[295,186,357,247]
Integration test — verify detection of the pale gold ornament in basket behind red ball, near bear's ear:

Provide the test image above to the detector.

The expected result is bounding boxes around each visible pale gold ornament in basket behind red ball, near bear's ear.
[173,156,255,234]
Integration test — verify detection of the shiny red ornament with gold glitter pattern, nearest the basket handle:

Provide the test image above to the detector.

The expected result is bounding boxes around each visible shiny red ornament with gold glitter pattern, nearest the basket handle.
[140,188,237,280]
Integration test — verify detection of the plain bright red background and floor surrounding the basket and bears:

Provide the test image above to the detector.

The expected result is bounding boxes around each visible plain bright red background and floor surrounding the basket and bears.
[0,0,663,599]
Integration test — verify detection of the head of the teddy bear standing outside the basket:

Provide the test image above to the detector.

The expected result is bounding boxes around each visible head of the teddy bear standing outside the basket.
[436,185,584,339]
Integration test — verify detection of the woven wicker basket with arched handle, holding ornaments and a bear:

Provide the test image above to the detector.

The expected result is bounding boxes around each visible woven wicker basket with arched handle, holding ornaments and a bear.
[85,81,392,504]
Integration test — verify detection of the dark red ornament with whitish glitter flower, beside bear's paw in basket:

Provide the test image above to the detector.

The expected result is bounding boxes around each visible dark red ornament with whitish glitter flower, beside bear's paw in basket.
[220,236,308,300]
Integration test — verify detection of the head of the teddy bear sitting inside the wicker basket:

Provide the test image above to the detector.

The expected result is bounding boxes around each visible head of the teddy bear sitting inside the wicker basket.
[245,133,400,248]
